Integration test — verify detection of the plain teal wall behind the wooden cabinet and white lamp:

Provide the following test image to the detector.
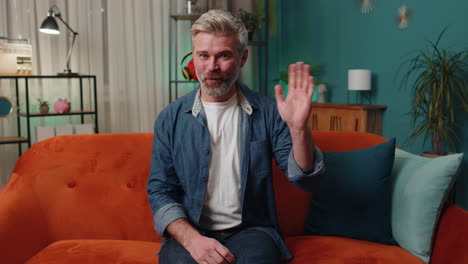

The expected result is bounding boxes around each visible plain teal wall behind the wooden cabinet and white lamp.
[276,0,468,209]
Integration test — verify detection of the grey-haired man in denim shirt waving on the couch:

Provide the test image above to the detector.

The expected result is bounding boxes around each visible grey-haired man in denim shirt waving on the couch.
[148,10,323,264]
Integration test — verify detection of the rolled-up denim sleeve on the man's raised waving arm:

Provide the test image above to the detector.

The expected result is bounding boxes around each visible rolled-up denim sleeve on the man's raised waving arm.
[287,146,325,191]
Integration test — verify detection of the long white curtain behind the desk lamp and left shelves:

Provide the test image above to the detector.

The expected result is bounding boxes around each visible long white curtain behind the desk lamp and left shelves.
[0,0,170,184]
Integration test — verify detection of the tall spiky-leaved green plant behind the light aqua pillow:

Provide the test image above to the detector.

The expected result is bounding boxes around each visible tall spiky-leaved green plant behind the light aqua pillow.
[403,28,468,156]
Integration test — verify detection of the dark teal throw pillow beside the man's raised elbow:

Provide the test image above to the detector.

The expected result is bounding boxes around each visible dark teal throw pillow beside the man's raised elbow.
[304,139,396,245]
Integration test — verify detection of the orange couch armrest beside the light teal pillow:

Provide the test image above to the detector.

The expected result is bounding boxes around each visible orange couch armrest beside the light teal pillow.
[431,205,468,264]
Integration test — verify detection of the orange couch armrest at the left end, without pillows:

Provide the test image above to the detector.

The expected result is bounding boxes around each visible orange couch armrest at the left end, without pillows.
[0,173,49,264]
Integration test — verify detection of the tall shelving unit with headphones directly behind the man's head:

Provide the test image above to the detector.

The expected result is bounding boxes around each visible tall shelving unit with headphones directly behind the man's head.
[169,0,269,102]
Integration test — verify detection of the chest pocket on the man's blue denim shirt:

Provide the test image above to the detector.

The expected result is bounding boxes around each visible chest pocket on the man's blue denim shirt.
[249,140,272,172]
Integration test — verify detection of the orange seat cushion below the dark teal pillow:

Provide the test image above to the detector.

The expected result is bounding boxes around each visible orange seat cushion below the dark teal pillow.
[286,236,425,264]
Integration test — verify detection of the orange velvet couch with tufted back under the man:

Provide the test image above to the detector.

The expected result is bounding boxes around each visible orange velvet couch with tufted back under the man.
[0,132,468,264]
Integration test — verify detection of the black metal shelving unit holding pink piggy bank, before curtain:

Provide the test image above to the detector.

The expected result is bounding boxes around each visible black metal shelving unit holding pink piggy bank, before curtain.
[0,75,99,155]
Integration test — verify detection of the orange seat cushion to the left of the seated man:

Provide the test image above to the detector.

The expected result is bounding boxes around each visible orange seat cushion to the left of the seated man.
[26,240,161,264]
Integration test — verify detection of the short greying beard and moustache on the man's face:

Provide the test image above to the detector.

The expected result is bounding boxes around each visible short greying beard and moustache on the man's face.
[195,67,240,97]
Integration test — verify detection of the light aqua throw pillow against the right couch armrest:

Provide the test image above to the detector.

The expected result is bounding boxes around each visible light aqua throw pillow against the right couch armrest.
[392,149,463,263]
